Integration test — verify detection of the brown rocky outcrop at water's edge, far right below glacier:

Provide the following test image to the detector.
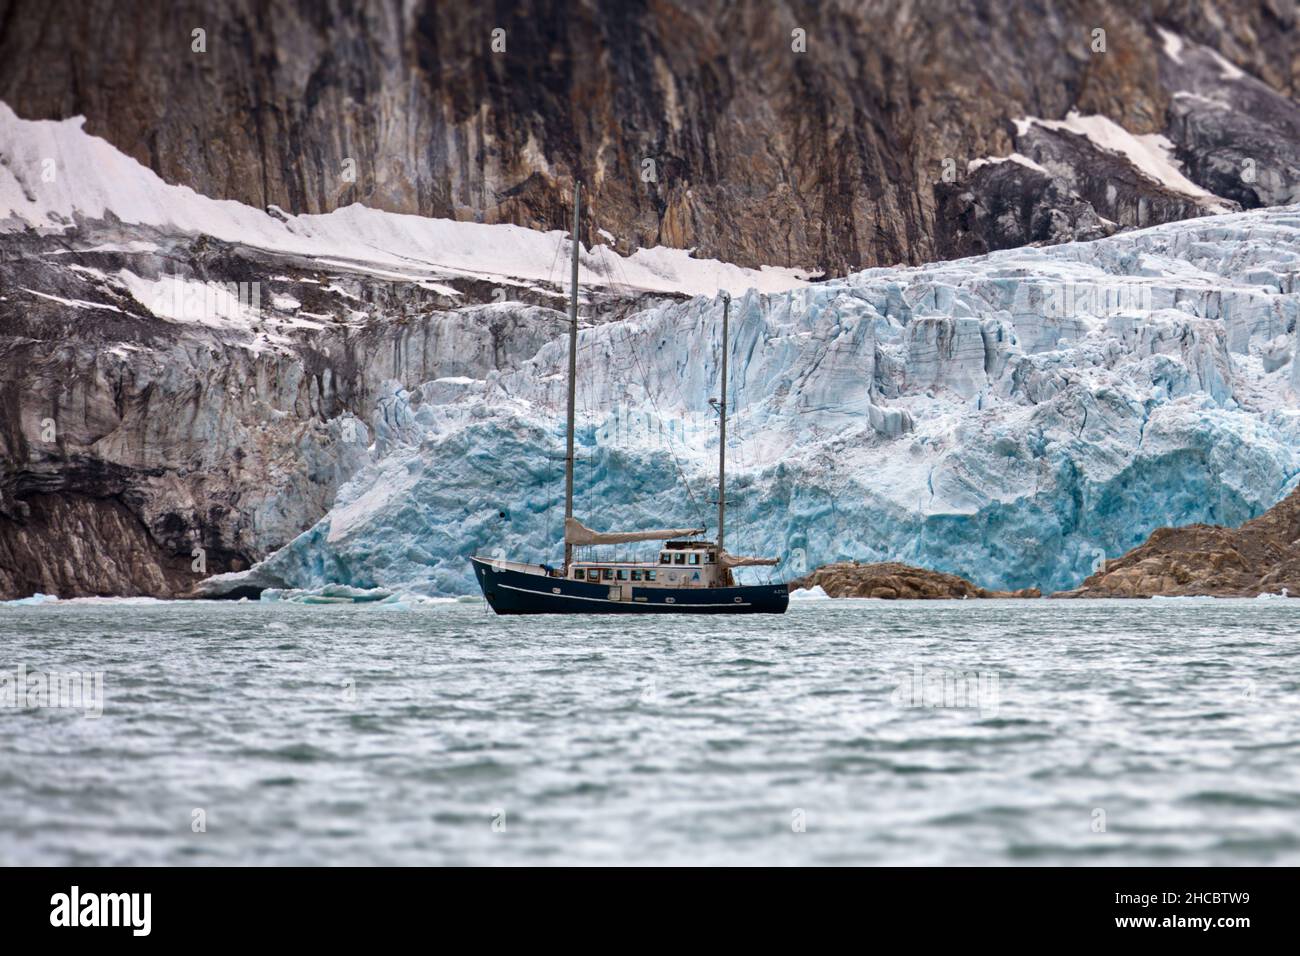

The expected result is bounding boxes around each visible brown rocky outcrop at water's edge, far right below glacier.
[1053,489,1300,597]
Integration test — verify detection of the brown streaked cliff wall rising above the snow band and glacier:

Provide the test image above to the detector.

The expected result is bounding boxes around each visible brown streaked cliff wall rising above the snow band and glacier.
[0,0,1300,274]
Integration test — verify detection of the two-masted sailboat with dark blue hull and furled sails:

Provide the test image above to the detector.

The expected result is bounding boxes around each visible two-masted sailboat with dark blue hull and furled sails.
[469,183,789,614]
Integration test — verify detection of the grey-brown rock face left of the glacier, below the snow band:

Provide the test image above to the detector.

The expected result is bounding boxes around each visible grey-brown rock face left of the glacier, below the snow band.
[0,234,582,598]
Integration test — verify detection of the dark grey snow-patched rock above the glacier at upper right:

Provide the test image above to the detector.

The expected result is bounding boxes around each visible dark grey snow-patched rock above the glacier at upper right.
[936,27,1300,254]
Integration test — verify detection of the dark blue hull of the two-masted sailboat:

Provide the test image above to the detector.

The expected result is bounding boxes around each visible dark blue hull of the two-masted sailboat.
[471,558,790,614]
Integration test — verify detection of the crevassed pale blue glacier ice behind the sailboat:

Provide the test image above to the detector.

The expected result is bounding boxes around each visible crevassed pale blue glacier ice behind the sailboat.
[205,206,1300,596]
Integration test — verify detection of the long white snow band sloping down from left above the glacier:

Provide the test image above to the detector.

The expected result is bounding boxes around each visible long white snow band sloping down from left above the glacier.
[0,103,809,295]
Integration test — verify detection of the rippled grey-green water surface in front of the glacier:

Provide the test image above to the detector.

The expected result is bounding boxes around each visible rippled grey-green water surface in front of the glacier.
[0,601,1300,865]
